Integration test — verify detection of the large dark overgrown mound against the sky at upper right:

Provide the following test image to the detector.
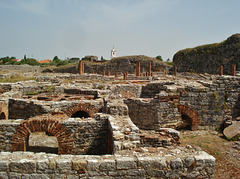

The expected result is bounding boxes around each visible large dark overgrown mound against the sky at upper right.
[173,34,240,74]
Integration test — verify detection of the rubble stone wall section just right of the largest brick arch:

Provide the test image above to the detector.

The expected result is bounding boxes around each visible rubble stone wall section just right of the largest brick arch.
[62,118,108,155]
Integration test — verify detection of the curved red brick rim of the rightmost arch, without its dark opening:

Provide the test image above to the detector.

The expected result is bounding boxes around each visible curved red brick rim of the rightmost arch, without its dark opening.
[178,105,201,130]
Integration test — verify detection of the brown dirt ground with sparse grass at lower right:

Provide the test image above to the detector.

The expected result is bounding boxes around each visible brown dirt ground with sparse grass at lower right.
[181,131,240,179]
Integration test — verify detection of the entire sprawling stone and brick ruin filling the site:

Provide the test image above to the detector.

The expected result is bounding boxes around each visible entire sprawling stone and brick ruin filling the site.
[0,64,240,178]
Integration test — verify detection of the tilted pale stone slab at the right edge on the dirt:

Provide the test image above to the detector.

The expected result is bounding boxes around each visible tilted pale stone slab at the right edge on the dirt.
[223,121,240,140]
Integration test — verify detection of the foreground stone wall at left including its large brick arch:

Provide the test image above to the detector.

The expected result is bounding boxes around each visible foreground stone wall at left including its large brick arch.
[0,116,108,155]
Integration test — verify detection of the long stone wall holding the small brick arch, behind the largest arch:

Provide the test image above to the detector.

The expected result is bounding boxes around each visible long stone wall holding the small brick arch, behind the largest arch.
[9,99,103,119]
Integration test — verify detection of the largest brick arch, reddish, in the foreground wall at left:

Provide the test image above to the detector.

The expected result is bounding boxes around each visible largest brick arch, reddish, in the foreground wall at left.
[11,117,74,154]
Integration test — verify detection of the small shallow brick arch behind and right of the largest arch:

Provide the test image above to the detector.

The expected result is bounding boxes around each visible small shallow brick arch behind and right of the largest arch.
[65,103,100,117]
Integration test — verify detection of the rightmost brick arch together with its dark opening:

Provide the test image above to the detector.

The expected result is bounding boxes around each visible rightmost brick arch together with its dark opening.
[177,105,201,130]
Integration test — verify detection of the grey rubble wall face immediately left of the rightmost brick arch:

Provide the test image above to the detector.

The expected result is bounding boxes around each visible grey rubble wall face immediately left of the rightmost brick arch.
[124,99,181,130]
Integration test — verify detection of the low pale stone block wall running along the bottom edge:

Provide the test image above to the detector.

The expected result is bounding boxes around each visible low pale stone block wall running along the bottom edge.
[0,152,215,179]
